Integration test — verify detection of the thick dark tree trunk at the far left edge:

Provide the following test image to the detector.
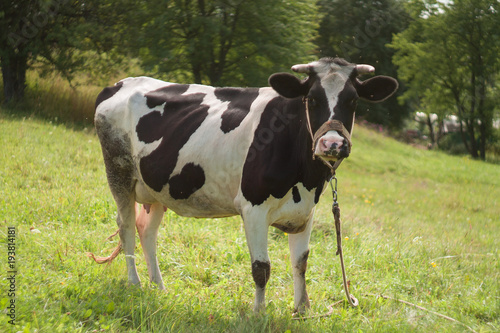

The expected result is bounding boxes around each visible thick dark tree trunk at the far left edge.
[0,52,28,103]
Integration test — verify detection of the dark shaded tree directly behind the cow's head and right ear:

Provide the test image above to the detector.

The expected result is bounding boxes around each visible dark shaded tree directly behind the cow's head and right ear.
[315,0,409,127]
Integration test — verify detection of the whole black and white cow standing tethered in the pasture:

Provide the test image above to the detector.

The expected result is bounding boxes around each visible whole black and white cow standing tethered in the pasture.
[95,58,398,311]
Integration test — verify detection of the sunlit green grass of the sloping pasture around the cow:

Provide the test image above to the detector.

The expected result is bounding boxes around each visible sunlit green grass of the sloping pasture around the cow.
[0,112,500,332]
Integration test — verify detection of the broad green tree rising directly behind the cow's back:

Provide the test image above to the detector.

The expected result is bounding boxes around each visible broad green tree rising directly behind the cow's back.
[122,0,316,86]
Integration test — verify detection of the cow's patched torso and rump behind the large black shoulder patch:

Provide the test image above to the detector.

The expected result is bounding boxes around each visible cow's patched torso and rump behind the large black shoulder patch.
[95,77,276,217]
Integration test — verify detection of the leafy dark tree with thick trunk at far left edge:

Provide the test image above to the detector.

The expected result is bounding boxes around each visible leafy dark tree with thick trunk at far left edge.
[0,0,127,102]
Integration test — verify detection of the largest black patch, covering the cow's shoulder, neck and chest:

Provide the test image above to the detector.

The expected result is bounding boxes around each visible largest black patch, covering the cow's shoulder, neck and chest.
[241,97,331,206]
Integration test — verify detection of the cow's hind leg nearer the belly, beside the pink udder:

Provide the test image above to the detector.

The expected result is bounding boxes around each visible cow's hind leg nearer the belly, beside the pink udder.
[136,203,165,290]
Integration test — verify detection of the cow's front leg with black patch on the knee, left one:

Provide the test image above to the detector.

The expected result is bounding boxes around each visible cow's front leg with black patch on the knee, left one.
[244,214,271,312]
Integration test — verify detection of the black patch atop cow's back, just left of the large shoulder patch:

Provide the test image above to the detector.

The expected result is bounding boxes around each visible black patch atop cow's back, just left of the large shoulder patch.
[214,88,259,133]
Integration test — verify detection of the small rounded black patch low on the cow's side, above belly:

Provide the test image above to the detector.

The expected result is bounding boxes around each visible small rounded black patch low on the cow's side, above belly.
[168,163,205,199]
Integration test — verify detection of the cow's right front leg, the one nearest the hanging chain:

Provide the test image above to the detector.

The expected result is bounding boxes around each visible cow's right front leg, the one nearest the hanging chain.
[288,213,313,313]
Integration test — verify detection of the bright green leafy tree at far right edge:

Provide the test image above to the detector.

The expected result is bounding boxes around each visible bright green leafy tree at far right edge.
[391,0,500,160]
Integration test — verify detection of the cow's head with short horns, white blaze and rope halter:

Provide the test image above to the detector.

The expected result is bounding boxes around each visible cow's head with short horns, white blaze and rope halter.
[269,58,398,161]
